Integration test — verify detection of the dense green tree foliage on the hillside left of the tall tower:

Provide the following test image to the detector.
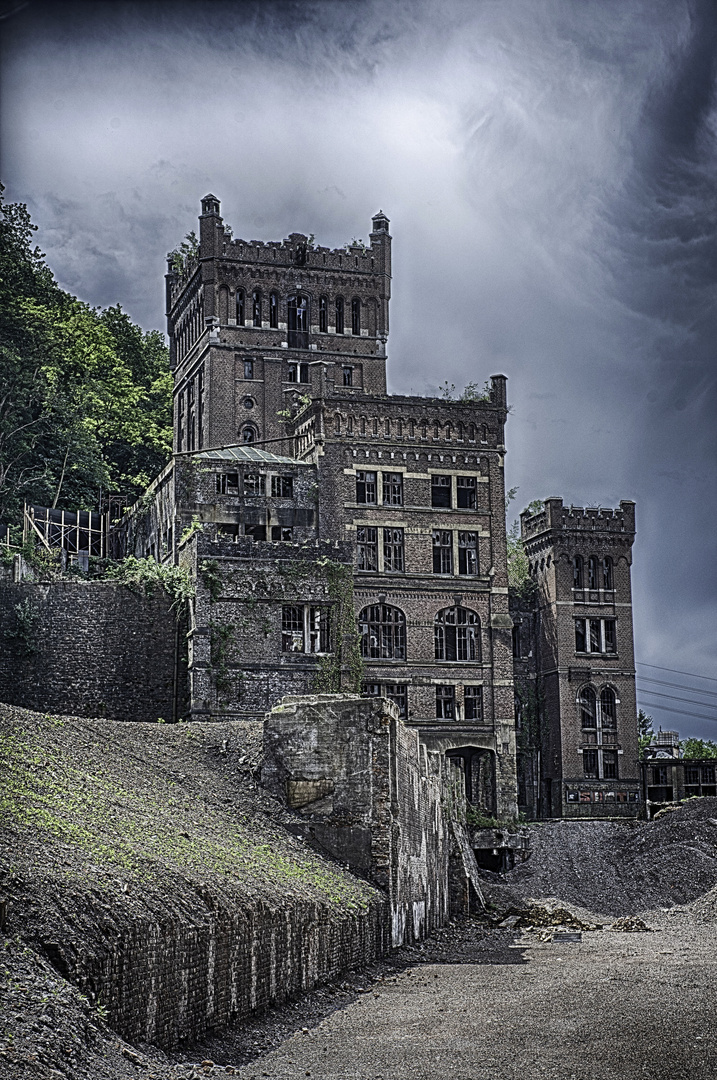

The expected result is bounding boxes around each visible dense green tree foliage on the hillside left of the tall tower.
[0,186,172,522]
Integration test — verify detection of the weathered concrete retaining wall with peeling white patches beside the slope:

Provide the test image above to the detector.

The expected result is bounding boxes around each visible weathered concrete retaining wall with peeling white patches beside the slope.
[262,694,454,945]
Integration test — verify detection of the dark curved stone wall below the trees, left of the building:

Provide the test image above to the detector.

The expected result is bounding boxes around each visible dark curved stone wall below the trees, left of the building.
[0,580,187,723]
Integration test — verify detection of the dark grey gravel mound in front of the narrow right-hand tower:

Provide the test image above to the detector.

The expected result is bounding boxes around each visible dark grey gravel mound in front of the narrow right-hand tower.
[479,798,717,918]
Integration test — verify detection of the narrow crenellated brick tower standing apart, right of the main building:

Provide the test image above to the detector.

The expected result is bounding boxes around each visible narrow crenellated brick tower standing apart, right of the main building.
[513,498,639,816]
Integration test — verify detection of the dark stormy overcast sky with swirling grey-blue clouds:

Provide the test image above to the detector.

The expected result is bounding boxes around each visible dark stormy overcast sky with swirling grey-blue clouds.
[1,0,717,738]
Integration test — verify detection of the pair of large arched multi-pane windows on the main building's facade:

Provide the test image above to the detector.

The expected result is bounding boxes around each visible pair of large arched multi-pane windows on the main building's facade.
[359,604,481,662]
